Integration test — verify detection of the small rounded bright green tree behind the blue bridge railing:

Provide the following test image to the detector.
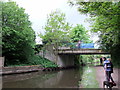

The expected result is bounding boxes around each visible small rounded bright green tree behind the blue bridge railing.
[70,24,92,43]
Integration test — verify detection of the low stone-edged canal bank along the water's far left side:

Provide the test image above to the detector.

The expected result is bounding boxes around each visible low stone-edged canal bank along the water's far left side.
[0,65,76,75]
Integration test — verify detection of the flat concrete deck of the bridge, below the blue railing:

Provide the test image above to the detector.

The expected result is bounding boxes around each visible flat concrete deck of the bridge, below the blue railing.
[58,49,110,55]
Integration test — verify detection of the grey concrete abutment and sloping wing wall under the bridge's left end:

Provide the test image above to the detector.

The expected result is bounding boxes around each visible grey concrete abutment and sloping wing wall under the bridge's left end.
[39,50,75,67]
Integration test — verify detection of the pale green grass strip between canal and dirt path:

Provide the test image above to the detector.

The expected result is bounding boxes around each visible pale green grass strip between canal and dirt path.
[79,66,99,88]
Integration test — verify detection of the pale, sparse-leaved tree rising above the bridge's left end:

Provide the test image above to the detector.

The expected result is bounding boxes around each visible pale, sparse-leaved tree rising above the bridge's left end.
[39,10,71,44]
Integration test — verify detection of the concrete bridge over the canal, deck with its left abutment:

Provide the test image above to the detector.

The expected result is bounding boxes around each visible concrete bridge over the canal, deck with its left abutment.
[39,46,110,67]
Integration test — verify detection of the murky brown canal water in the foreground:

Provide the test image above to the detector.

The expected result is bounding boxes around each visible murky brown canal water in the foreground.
[2,69,82,88]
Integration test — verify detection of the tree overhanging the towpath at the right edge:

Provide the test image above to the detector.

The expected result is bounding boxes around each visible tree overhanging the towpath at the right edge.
[68,0,120,65]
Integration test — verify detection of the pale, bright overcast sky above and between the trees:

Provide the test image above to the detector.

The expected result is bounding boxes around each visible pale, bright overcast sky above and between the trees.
[12,0,97,43]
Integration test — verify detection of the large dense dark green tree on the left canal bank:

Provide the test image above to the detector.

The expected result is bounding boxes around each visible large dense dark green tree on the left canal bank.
[2,1,35,65]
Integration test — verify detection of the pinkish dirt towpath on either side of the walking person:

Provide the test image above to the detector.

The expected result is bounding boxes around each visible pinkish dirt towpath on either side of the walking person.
[95,66,120,90]
